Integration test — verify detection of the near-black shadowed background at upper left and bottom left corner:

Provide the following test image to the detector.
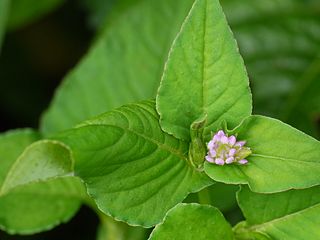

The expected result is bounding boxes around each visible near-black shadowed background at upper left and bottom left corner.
[0,1,98,240]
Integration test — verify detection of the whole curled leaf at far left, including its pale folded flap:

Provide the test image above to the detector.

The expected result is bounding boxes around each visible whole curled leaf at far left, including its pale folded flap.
[0,129,86,234]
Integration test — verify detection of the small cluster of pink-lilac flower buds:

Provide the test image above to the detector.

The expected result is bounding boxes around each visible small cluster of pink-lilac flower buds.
[206,130,251,165]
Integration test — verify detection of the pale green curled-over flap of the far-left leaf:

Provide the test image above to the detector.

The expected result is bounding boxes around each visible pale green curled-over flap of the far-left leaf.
[0,140,73,196]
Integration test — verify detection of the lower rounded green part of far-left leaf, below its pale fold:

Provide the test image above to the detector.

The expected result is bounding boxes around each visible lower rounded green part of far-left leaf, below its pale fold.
[0,177,85,234]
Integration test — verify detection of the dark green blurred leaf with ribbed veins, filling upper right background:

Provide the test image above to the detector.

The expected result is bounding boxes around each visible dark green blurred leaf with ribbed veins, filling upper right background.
[221,0,320,136]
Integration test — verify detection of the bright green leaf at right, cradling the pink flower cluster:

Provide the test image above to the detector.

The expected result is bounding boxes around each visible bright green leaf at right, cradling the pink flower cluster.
[205,116,320,193]
